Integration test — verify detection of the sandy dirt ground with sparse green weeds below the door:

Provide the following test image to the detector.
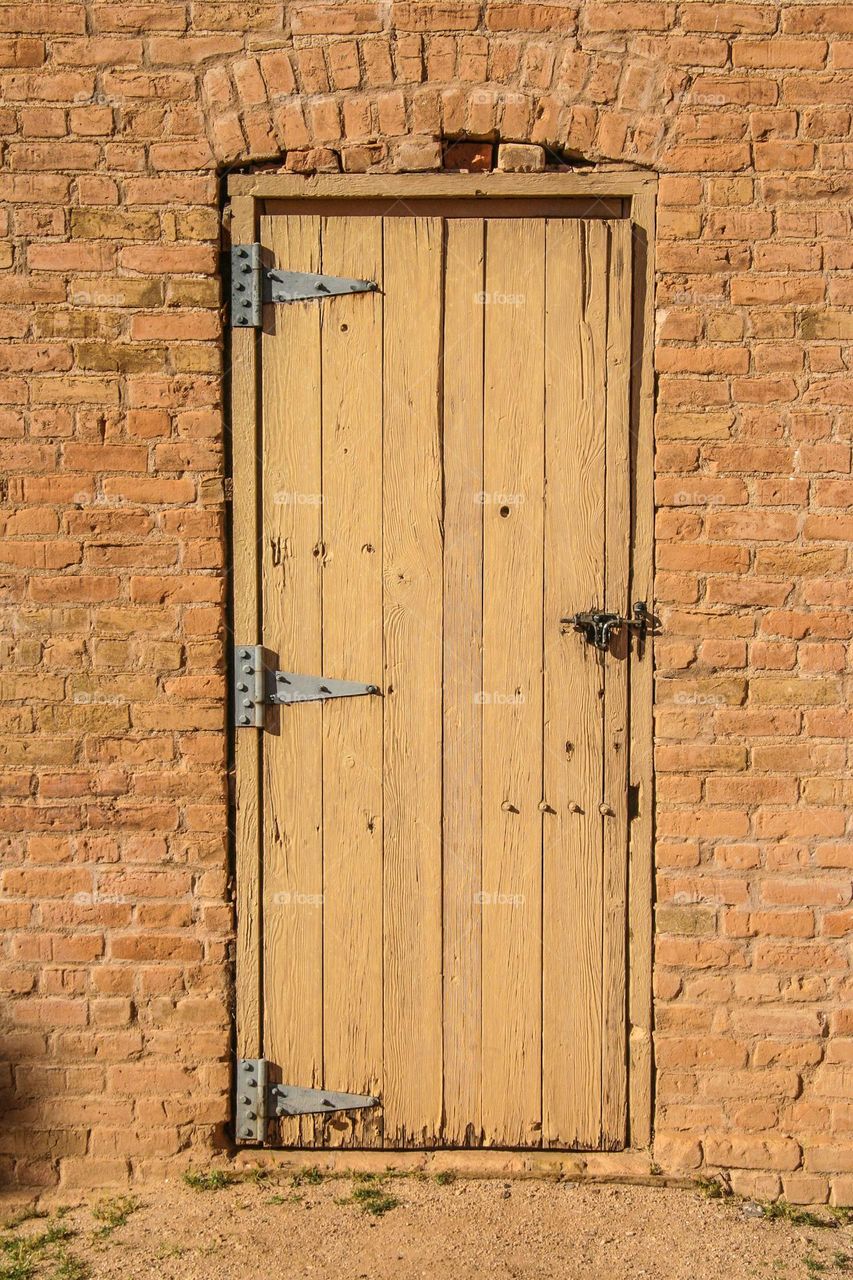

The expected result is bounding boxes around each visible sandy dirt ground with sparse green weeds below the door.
[0,1171,853,1280]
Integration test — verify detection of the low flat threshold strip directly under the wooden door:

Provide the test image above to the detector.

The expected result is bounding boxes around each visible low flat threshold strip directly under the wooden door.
[234,1147,676,1187]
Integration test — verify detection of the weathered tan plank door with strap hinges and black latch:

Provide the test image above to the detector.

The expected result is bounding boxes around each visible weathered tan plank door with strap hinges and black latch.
[245,214,633,1149]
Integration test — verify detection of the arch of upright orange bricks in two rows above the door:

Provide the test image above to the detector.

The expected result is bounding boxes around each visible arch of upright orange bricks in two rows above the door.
[174,41,690,173]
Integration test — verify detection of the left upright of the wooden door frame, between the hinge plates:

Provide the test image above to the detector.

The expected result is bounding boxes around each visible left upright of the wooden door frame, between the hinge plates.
[231,196,261,1057]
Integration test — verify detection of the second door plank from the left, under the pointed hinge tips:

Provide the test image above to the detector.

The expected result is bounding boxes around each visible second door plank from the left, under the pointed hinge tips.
[319,218,383,1147]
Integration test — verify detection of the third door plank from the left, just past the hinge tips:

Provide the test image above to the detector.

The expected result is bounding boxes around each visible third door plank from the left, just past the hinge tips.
[383,218,443,1147]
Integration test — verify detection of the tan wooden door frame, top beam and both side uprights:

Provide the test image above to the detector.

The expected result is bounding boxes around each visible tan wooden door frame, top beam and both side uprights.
[227,169,657,1157]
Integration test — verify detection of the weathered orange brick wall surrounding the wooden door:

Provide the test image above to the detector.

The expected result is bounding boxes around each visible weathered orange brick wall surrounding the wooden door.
[0,0,853,1203]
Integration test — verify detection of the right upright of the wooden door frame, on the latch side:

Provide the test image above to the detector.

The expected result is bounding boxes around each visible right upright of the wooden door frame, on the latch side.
[628,191,654,1147]
